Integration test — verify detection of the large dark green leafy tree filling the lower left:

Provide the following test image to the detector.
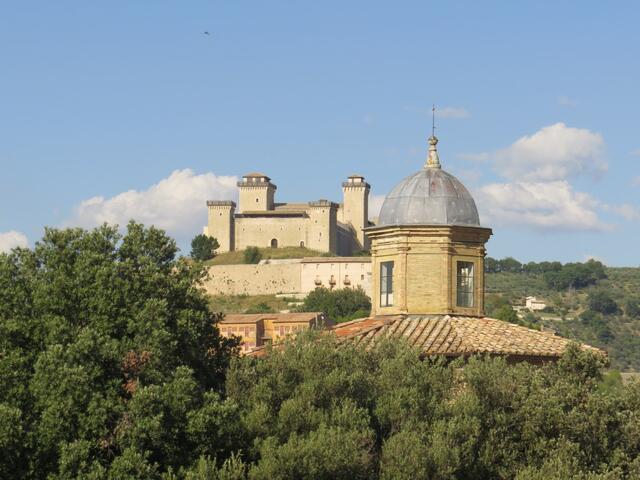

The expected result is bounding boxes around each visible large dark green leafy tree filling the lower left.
[0,222,236,478]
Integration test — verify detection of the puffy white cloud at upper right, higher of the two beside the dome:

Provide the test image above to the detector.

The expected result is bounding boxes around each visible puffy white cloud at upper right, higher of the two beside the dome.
[493,123,608,181]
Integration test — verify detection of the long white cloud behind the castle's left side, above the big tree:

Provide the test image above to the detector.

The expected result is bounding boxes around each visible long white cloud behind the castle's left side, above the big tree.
[66,169,238,240]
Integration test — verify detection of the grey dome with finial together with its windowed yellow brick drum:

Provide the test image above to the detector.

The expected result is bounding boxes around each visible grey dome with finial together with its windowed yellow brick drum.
[365,135,492,316]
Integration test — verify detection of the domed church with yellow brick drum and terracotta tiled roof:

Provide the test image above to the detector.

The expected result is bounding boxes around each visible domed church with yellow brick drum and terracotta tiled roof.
[241,131,606,363]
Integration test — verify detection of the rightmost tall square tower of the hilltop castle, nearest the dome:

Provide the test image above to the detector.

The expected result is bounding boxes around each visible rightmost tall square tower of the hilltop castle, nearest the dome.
[342,175,371,252]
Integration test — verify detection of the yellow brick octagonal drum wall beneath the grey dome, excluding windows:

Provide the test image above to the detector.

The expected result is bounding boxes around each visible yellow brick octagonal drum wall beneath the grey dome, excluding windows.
[369,226,491,316]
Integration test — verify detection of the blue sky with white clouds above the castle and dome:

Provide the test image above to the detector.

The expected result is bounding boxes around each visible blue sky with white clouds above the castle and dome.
[0,1,640,266]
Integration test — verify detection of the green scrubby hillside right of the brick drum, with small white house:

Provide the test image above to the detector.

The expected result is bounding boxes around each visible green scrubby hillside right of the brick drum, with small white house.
[485,259,640,371]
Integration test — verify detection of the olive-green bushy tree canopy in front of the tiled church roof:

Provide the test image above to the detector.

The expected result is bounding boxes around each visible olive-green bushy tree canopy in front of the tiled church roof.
[219,332,640,480]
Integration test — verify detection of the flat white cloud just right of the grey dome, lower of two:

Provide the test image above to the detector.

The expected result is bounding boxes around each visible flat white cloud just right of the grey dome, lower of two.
[476,180,611,231]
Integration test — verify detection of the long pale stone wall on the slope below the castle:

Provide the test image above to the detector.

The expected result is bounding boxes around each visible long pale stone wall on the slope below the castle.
[205,257,371,295]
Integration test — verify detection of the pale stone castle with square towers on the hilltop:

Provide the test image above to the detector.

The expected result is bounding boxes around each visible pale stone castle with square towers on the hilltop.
[204,173,371,255]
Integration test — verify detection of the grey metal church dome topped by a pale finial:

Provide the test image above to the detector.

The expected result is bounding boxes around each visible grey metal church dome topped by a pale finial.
[378,135,480,227]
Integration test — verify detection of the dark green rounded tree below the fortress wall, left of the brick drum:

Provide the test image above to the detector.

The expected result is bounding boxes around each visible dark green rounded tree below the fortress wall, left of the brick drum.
[299,287,371,322]
